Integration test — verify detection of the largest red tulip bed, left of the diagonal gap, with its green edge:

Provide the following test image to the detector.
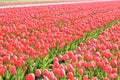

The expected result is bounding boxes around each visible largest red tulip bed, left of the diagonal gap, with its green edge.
[0,2,120,80]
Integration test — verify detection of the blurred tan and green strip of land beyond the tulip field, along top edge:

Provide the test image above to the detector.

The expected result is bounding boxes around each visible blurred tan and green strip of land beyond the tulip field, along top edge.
[0,0,104,6]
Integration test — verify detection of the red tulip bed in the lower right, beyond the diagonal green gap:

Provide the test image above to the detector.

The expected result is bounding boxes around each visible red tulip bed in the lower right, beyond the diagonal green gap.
[26,23,120,80]
